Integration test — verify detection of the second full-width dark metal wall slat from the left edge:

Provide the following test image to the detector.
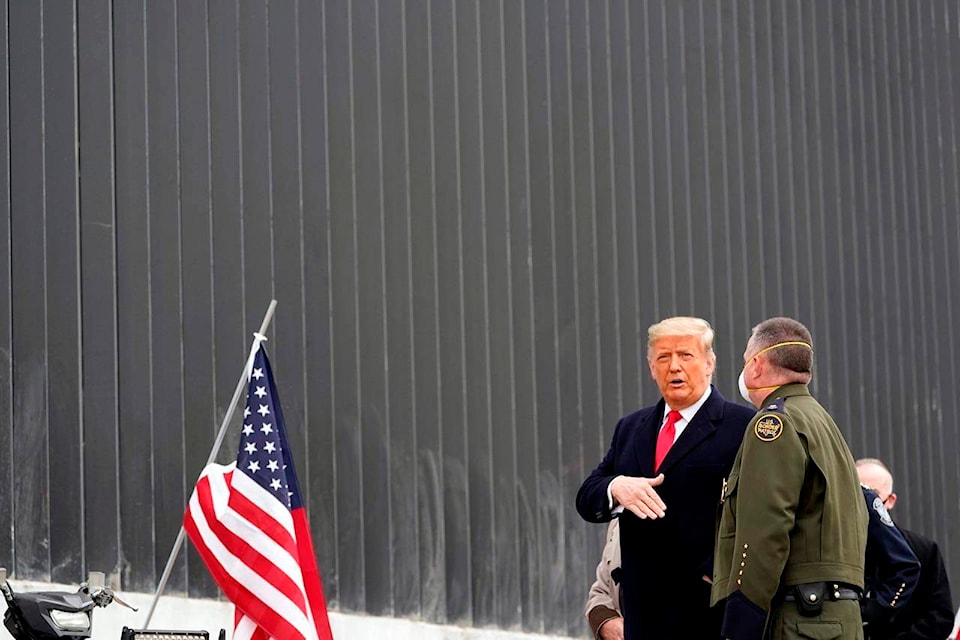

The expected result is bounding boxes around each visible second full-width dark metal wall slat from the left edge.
[42,2,85,581]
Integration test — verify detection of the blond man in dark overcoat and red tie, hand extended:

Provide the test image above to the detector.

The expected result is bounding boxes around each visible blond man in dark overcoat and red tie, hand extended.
[577,317,754,640]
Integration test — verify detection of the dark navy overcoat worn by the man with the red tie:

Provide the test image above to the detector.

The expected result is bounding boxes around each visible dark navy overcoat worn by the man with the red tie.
[577,388,755,640]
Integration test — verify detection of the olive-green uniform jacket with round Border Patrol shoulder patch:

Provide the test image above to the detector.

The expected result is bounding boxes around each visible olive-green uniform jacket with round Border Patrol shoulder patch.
[711,384,868,640]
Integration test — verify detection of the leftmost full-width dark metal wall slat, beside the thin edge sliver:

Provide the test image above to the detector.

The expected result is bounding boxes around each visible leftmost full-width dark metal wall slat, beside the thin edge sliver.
[8,3,51,578]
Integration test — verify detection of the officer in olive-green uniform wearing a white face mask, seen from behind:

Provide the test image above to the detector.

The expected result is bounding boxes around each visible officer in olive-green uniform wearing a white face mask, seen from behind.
[711,318,867,640]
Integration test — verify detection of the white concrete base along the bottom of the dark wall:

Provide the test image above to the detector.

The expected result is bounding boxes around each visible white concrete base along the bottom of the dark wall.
[9,579,586,640]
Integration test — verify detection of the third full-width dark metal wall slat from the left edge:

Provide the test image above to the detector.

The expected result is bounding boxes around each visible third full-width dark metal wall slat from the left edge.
[78,0,120,583]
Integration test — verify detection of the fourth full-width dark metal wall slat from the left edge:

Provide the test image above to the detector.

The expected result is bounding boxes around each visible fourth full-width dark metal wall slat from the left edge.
[113,2,156,591]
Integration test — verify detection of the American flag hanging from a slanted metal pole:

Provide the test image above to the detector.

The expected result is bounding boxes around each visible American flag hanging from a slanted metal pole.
[183,346,333,640]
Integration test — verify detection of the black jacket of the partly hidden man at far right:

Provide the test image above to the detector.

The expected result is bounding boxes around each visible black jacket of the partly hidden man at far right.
[870,527,953,640]
